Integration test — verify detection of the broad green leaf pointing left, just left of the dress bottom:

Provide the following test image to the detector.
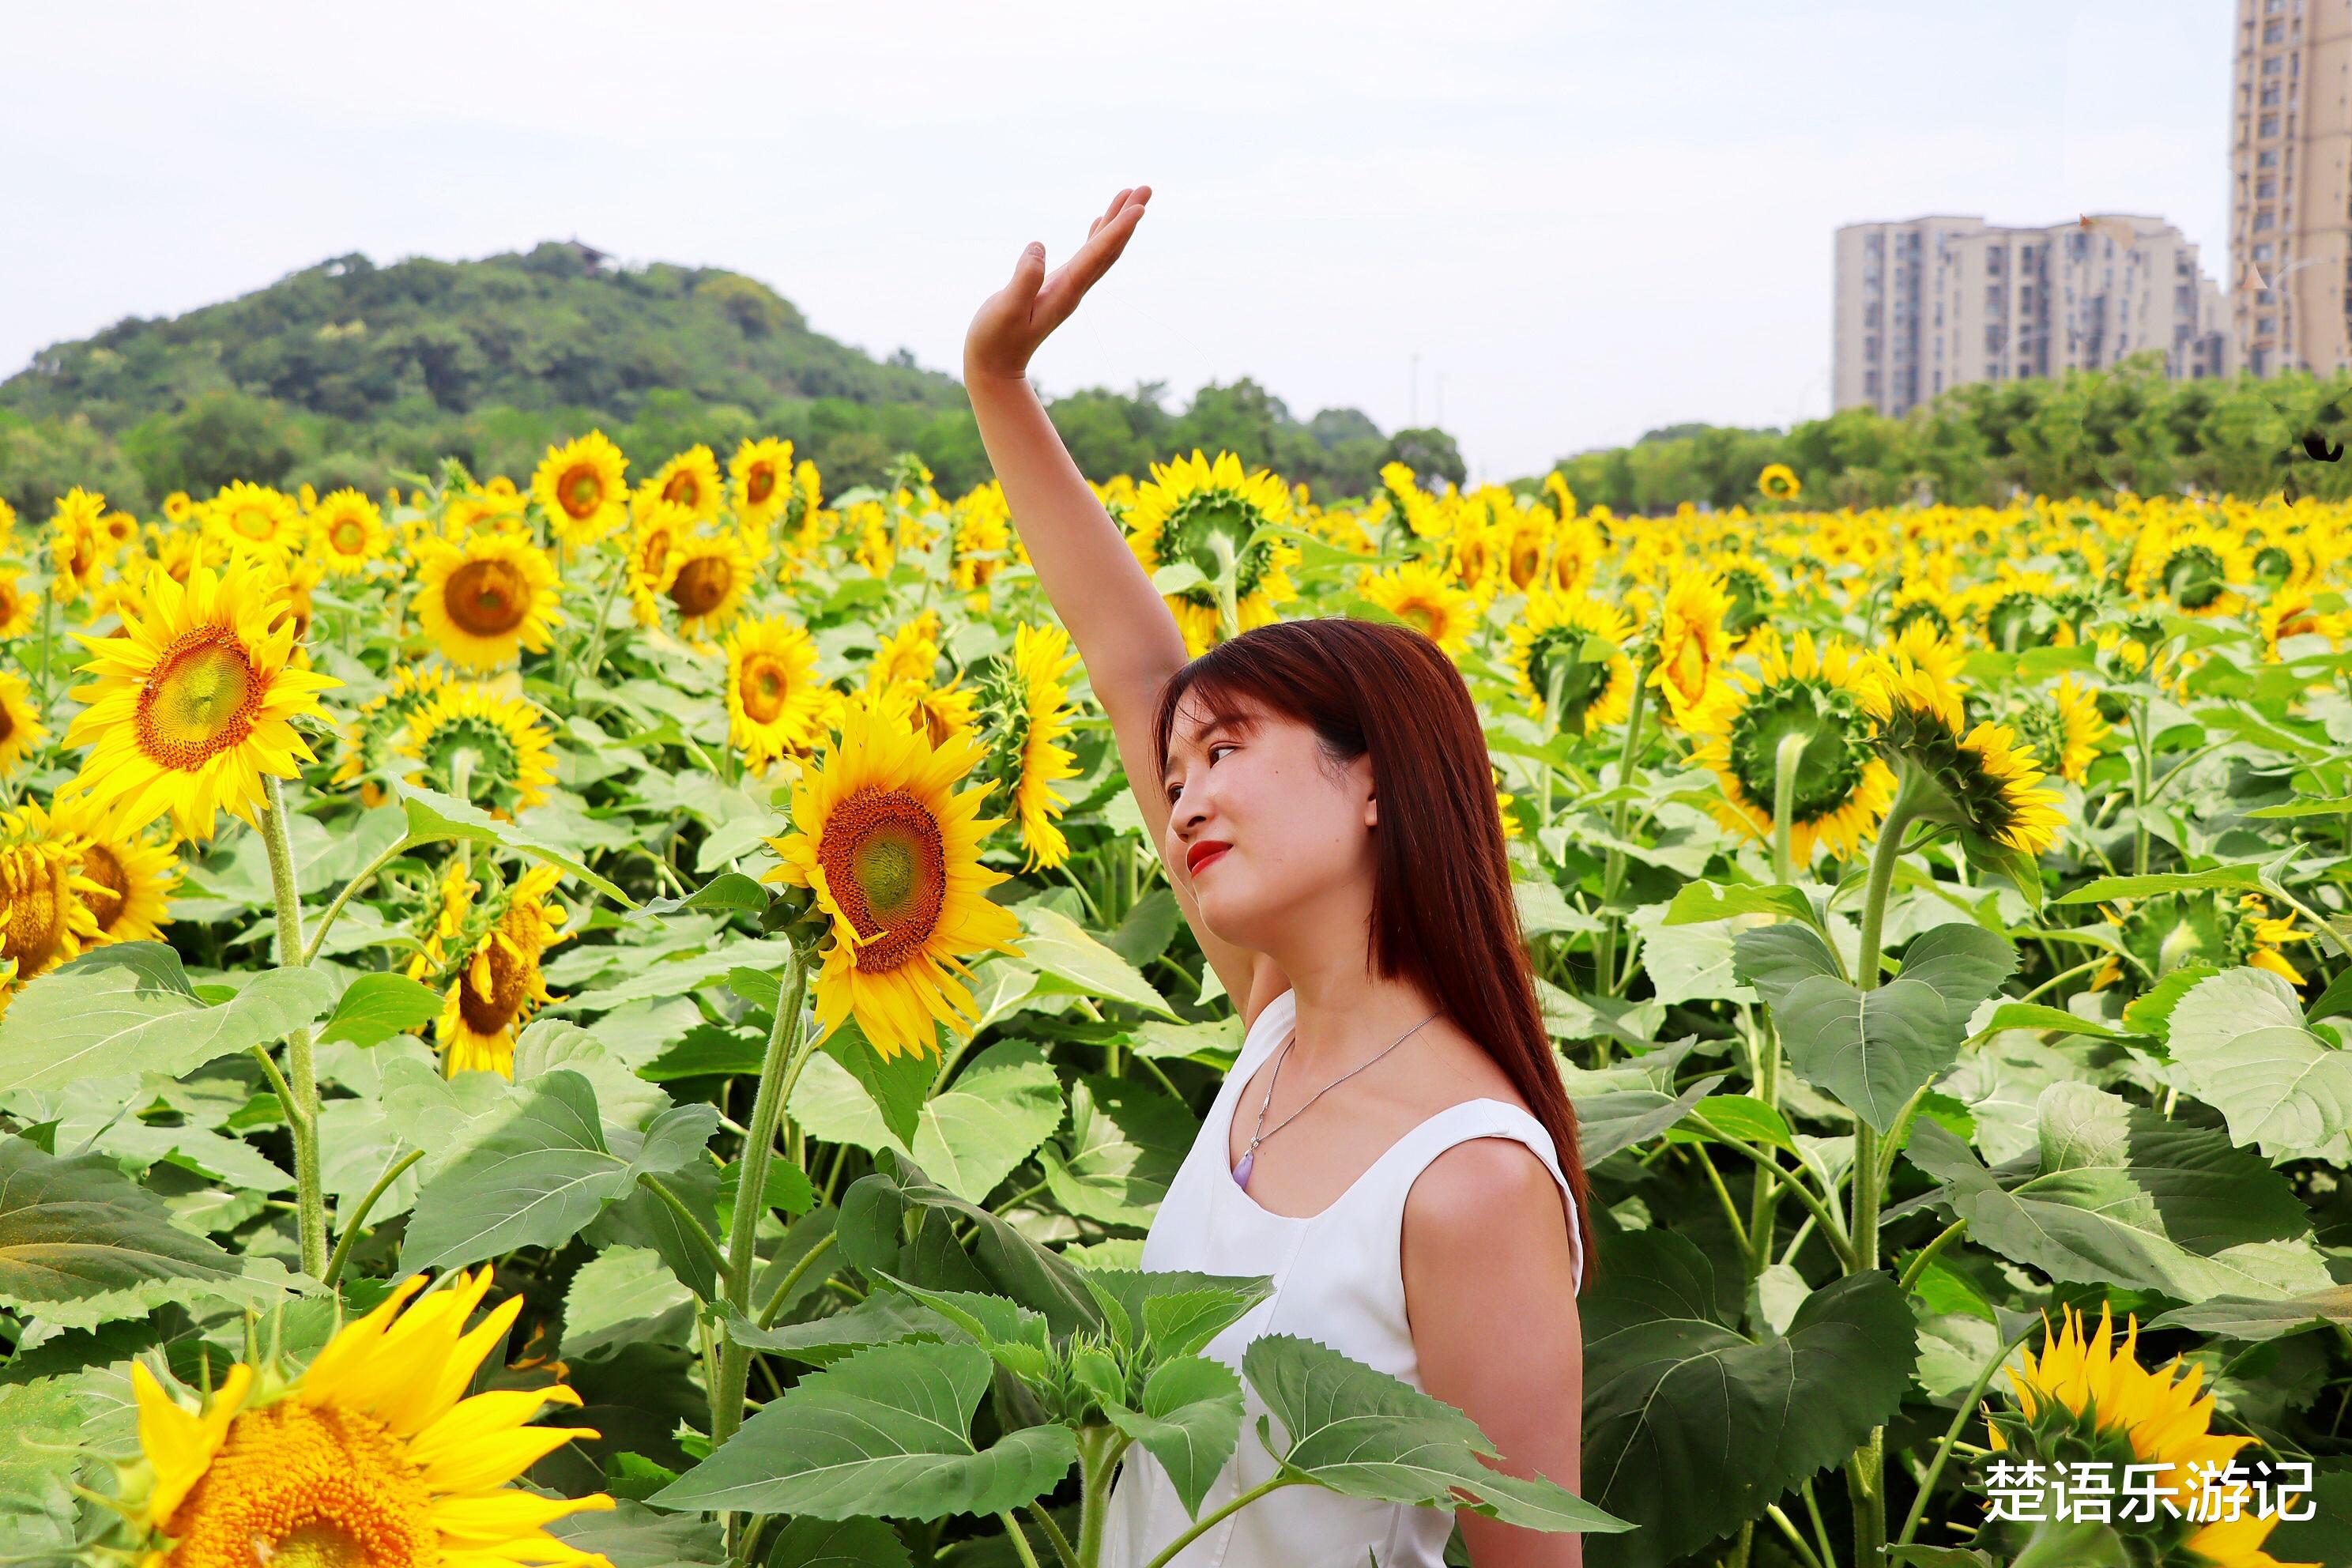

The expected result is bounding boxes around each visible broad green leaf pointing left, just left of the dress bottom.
[646,1342,1077,1519]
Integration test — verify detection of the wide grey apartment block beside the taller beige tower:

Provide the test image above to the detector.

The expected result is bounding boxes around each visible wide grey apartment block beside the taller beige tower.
[1832,217,2230,416]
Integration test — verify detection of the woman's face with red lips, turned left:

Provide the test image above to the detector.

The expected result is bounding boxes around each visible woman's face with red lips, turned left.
[1162,703,1378,952]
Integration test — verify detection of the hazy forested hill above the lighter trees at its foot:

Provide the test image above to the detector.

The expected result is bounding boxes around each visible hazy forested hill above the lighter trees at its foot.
[0,242,962,442]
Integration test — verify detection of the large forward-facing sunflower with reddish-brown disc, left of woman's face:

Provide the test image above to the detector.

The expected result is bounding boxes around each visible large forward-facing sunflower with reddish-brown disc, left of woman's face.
[767,703,1021,1058]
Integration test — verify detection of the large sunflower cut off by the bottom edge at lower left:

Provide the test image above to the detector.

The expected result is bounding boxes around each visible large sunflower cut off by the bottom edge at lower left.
[125,1267,614,1568]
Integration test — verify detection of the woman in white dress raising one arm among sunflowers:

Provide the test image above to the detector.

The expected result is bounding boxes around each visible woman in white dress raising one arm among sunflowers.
[964,186,1590,1568]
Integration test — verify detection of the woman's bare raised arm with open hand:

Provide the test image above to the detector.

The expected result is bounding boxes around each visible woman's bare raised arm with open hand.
[964,186,1258,1008]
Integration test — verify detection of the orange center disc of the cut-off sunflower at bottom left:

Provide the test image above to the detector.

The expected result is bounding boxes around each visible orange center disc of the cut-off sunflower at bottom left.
[153,1399,442,1568]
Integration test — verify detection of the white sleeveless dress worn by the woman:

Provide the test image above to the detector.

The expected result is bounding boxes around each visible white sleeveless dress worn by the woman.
[1103,989,1585,1568]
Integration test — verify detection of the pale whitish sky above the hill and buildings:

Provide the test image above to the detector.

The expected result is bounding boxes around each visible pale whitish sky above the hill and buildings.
[0,0,2234,480]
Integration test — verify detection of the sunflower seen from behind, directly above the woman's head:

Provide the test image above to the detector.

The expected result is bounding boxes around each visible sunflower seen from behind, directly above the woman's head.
[1127,449,1307,656]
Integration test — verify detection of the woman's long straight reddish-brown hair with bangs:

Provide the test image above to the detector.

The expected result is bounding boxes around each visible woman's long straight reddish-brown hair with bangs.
[1155,616,1592,1272]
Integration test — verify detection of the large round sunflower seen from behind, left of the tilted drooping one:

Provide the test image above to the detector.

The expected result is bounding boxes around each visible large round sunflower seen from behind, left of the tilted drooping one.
[1691,630,1896,868]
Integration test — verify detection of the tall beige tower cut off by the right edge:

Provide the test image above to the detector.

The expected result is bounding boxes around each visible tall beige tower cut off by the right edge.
[2230,0,2352,376]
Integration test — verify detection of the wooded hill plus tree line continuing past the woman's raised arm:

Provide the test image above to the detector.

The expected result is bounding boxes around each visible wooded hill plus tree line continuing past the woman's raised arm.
[0,242,1463,517]
